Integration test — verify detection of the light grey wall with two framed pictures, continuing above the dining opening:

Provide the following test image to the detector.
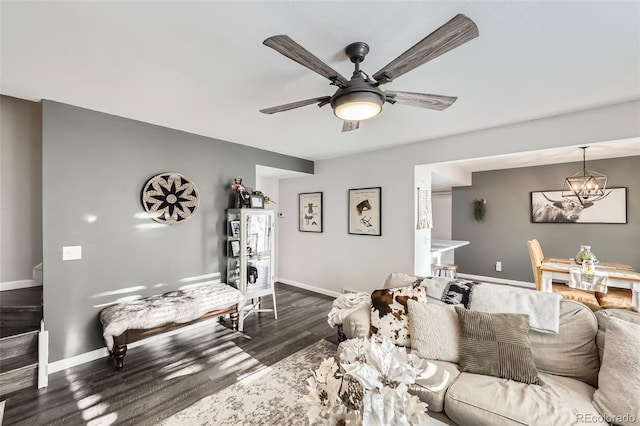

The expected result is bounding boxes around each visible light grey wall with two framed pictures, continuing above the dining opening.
[278,101,640,293]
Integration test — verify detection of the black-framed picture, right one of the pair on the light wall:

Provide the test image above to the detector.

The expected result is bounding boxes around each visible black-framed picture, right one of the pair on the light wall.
[349,186,382,236]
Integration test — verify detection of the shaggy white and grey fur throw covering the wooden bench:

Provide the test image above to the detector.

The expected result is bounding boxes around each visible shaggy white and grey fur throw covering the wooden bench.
[100,283,245,351]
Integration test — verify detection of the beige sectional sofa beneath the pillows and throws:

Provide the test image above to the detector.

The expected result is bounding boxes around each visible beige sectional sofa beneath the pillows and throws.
[342,276,640,426]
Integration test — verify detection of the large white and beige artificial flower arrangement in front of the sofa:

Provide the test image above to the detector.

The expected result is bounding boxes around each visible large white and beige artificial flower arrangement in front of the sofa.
[305,336,429,425]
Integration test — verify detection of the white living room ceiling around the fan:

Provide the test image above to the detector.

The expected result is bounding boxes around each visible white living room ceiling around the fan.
[0,0,640,174]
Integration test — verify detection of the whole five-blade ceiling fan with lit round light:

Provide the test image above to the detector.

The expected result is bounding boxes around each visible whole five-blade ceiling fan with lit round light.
[260,14,478,132]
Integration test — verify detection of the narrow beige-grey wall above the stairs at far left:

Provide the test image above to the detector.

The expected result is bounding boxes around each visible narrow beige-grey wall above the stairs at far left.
[0,96,42,283]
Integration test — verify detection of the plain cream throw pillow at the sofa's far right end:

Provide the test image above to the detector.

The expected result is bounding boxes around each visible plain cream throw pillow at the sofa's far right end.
[593,317,640,425]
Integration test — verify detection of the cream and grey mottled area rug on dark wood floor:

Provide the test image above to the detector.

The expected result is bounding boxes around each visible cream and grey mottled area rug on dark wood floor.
[160,340,337,426]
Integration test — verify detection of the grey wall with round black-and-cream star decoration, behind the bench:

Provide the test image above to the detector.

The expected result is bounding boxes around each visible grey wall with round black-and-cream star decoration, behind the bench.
[43,101,314,362]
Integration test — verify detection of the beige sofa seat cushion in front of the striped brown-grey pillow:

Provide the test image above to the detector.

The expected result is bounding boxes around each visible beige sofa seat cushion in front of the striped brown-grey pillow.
[445,373,607,426]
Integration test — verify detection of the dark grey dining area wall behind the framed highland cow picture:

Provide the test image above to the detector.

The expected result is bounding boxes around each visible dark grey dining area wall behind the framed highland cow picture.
[452,155,640,282]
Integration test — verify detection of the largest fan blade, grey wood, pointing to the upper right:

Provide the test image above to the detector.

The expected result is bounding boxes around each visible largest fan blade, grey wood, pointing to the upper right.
[373,14,479,84]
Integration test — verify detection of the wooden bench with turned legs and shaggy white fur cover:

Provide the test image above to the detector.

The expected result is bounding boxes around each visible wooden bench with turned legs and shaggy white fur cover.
[100,283,245,371]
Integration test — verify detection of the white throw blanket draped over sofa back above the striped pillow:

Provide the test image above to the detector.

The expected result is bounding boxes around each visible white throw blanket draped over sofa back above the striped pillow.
[469,283,562,333]
